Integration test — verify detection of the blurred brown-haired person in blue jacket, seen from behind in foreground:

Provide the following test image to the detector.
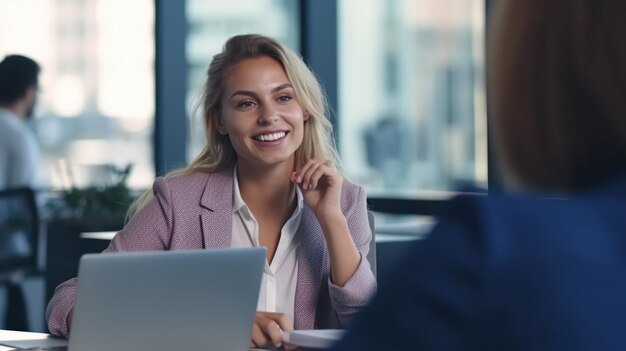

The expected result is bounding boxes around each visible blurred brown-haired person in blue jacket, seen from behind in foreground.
[324,0,626,351]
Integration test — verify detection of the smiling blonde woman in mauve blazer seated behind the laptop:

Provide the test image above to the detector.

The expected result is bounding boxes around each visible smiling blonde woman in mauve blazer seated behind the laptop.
[47,35,376,347]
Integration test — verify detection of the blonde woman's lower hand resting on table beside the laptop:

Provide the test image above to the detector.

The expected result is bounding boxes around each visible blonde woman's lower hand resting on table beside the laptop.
[251,312,293,348]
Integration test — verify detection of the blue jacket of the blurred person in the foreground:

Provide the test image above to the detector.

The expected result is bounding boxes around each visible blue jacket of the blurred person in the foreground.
[334,177,626,351]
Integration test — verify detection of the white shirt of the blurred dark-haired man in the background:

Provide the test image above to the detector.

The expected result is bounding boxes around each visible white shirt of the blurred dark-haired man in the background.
[0,107,39,190]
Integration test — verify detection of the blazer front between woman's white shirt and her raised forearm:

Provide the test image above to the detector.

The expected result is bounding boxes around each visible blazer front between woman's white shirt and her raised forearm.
[294,207,328,329]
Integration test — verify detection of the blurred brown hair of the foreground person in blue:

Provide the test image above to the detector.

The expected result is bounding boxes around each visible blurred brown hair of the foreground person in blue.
[488,0,626,191]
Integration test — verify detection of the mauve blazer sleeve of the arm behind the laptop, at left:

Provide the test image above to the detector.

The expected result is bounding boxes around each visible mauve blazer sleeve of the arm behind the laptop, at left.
[46,178,172,336]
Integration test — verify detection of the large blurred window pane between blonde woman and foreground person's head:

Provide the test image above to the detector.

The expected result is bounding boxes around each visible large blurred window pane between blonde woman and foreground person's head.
[338,0,487,197]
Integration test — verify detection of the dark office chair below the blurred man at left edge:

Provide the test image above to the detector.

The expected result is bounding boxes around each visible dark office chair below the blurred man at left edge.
[0,188,39,330]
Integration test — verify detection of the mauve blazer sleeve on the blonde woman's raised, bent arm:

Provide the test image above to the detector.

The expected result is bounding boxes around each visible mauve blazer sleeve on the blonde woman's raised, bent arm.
[328,186,376,327]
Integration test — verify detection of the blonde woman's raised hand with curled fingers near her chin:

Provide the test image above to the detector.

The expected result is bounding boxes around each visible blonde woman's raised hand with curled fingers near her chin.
[291,160,343,220]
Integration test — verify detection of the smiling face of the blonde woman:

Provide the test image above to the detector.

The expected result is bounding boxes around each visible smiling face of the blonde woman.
[217,57,306,170]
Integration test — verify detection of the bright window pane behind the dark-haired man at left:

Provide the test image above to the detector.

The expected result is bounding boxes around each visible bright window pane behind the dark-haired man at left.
[0,0,154,188]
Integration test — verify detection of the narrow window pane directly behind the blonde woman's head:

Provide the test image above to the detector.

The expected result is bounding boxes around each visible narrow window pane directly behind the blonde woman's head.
[187,0,300,159]
